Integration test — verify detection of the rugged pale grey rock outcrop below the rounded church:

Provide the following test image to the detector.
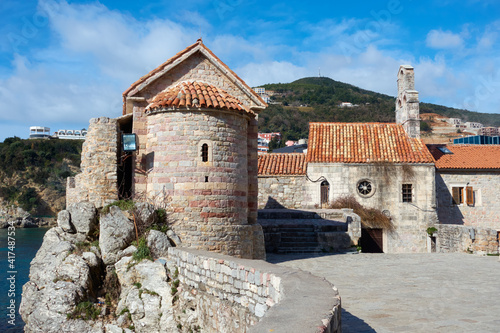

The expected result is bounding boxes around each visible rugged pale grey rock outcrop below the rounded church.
[19,202,181,333]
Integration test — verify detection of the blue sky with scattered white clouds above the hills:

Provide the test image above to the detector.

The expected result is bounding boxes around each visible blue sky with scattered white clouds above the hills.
[0,0,500,141]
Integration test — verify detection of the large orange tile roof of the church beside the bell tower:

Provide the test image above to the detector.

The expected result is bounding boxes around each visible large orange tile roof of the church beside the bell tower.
[307,123,434,163]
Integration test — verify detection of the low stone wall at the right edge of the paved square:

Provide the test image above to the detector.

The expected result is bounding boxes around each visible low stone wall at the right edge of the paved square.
[436,224,499,255]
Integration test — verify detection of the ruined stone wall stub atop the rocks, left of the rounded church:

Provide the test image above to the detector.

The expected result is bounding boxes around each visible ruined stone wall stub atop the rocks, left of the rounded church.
[66,117,119,207]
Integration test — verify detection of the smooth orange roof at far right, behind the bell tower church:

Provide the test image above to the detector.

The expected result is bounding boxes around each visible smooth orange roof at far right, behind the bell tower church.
[427,145,500,169]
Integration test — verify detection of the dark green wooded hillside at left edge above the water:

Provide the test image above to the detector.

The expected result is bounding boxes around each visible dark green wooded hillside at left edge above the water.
[0,137,83,216]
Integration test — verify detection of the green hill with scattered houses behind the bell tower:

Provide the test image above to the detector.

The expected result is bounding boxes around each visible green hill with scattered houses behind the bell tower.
[259,77,500,143]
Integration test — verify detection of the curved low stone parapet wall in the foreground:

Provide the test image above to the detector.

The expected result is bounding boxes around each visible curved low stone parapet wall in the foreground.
[169,248,341,333]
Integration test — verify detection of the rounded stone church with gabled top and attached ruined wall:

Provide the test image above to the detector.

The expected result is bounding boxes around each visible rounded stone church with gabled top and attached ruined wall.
[67,39,267,259]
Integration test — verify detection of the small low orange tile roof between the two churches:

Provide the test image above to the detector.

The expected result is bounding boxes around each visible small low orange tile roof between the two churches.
[258,153,306,176]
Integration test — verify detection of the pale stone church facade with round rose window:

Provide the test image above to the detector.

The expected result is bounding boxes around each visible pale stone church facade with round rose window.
[305,163,437,252]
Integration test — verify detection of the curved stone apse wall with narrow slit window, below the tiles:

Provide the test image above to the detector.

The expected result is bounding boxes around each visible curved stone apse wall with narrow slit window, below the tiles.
[137,110,265,258]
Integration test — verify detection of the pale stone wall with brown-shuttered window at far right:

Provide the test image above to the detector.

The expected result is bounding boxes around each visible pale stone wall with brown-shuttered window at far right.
[436,171,500,230]
